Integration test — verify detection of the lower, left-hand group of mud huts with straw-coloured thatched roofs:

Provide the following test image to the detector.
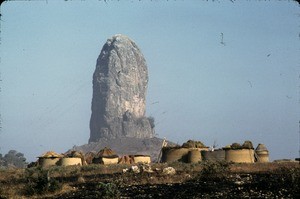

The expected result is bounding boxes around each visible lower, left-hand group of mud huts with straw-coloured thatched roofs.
[37,147,151,168]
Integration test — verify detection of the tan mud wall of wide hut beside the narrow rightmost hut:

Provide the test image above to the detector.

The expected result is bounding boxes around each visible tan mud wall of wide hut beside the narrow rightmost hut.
[225,149,254,163]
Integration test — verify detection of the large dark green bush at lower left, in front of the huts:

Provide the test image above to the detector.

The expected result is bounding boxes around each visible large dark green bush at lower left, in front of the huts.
[24,167,62,196]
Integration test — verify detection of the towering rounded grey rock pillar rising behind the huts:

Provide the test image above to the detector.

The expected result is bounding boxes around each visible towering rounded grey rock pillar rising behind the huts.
[89,35,154,142]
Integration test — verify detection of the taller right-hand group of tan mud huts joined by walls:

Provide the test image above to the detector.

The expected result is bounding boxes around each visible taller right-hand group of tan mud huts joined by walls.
[161,140,269,163]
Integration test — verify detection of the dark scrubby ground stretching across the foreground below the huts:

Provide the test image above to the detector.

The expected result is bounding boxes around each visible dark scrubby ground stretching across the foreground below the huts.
[0,162,300,199]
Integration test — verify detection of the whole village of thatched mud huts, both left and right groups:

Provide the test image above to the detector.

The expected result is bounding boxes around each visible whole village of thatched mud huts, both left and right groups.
[38,140,269,167]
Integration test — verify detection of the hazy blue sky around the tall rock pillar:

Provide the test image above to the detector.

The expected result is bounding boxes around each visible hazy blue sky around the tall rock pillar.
[0,0,300,161]
